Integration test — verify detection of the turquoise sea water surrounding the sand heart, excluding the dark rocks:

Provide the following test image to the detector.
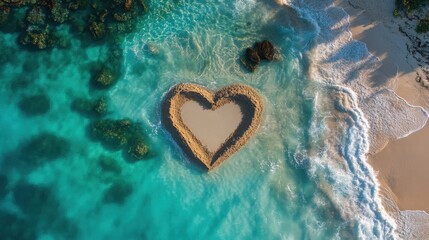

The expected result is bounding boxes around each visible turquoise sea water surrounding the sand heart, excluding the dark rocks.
[0,0,393,239]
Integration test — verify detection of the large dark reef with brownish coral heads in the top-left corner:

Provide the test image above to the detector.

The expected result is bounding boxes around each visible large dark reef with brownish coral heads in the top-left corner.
[0,0,147,49]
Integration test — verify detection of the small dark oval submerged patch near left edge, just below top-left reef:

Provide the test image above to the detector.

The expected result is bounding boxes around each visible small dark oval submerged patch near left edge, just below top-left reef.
[18,94,51,116]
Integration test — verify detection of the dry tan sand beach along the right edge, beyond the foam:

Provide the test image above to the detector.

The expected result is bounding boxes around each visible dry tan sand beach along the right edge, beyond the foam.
[335,0,429,233]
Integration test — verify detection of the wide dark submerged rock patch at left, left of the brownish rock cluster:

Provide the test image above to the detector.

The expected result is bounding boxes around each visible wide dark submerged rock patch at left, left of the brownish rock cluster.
[21,133,70,165]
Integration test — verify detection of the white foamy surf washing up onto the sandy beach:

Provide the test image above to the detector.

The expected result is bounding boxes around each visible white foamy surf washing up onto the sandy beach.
[284,0,428,239]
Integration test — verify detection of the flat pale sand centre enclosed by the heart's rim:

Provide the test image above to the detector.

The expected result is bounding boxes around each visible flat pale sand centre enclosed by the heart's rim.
[180,100,243,152]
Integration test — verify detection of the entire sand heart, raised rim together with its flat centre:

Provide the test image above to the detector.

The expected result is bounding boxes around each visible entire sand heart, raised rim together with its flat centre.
[162,83,263,171]
